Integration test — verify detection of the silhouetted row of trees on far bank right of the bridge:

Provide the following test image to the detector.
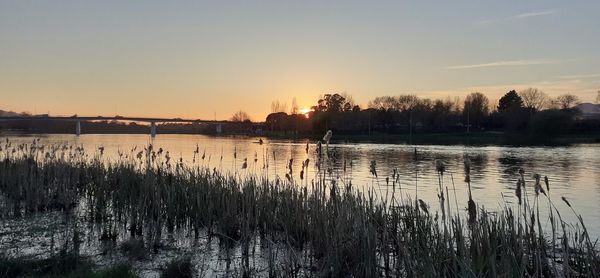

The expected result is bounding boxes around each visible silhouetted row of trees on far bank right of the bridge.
[265,88,600,134]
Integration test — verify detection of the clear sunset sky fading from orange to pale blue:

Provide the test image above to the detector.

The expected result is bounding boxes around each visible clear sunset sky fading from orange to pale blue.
[0,0,600,121]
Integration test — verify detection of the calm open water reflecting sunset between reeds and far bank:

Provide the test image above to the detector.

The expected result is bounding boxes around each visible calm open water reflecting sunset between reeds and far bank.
[0,134,600,238]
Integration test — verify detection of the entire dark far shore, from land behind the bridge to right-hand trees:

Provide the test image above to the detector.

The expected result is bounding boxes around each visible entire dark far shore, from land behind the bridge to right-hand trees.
[0,88,600,144]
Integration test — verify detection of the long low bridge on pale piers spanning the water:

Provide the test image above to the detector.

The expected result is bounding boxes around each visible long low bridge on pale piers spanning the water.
[0,116,228,137]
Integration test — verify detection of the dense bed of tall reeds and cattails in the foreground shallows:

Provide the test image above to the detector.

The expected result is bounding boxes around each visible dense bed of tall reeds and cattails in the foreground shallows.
[0,142,600,277]
